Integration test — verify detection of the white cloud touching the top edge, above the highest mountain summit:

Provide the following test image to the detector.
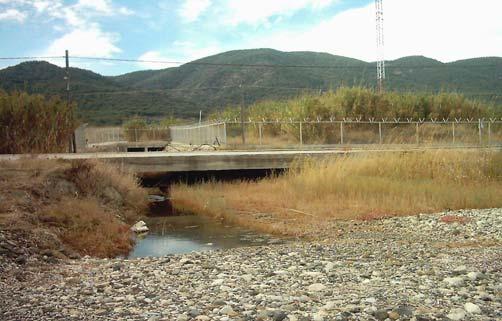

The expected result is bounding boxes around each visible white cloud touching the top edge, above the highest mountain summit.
[223,0,338,26]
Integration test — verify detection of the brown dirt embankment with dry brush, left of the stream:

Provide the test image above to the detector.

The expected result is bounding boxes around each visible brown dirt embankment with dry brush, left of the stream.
[0,160,147,264]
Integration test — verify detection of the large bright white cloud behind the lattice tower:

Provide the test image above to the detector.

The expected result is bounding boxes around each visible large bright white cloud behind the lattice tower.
[247,0,502,61]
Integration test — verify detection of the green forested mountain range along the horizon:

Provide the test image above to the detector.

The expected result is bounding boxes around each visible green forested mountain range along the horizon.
[0,49,502,124]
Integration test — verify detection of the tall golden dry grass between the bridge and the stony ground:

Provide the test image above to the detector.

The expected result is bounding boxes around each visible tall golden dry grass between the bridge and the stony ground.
[171,151,502,235]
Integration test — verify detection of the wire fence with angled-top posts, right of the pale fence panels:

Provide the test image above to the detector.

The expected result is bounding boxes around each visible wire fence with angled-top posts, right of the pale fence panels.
[226,120,502,147]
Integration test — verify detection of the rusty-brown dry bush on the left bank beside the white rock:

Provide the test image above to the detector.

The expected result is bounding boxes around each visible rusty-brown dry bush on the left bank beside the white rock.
[39,198,133,257]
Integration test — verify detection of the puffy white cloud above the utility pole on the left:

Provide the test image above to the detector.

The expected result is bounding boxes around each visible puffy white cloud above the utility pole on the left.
[43,25,121,57]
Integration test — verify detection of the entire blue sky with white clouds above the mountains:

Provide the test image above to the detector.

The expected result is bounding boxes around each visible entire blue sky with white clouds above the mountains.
[0,0,502,75]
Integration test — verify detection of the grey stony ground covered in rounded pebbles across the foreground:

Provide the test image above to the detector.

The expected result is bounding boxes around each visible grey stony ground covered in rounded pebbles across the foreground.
[0,209,502,321]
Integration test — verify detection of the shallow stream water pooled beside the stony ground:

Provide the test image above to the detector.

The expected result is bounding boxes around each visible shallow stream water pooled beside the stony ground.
[129,215,282,258]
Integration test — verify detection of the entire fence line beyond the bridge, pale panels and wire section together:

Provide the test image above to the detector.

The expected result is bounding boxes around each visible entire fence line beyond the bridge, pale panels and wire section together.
[85,119,502,149]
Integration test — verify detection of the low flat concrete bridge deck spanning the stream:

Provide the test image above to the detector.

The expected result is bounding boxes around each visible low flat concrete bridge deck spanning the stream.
[0,147,500,174]
